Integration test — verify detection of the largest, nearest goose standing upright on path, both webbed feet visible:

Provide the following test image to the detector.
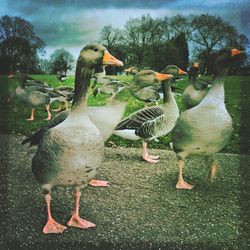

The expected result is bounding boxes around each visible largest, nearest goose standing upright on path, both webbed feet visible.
[32,44,123,234]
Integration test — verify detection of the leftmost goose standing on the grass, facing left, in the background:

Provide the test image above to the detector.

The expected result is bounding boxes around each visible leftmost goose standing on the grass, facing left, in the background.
[8,72,61,121]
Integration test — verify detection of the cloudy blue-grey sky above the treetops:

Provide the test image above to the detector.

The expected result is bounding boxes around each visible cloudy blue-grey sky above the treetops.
[0,0,250,58]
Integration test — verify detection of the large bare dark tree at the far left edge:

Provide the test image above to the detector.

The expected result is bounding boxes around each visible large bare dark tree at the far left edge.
[0,16,45,73]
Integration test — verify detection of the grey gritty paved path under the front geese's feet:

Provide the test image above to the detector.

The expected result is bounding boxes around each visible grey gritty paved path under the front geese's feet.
[0,135,250,250]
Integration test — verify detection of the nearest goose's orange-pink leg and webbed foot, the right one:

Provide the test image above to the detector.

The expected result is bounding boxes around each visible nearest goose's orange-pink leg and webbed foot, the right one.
[67,189,96,229]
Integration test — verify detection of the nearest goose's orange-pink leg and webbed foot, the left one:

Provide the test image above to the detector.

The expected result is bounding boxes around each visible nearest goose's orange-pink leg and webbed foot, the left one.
[43,194,67,234]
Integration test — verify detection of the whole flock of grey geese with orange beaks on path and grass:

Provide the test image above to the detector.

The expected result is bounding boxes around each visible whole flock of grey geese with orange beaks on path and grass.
[8,44,242,234]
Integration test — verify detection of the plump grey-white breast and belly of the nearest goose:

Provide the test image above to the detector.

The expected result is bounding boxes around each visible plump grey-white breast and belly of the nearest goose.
[32,115,104,186]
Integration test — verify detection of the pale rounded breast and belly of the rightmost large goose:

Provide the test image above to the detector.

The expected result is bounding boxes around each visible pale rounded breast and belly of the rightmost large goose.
[173,105,233,155]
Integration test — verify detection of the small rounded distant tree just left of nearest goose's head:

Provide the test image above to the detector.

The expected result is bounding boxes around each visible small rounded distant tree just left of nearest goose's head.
[50,48,74,75]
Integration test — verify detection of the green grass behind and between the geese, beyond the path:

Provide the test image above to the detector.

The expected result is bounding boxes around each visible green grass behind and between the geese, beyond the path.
[0,75,250,154]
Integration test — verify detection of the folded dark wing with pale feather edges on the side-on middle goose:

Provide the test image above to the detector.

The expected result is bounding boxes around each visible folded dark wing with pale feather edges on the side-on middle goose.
[116,106,164,139]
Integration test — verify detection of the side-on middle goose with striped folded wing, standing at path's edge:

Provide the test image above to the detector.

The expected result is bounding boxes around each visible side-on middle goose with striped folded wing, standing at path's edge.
[114,72,176,163]
